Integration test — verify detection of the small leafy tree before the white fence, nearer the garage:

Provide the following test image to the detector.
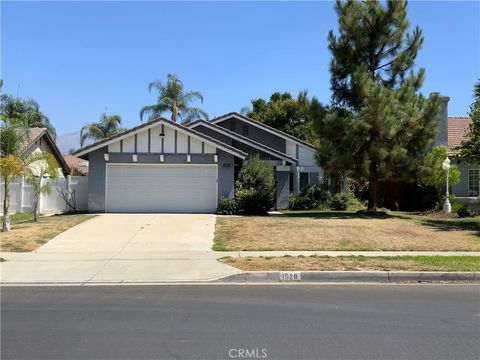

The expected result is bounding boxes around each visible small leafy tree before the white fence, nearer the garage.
[25,153,58,221]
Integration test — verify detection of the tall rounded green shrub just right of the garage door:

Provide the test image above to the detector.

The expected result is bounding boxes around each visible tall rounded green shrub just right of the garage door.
[235,155,275,215]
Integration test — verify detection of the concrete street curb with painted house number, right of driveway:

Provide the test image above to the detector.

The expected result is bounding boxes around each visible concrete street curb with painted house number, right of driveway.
[215,271,480,284]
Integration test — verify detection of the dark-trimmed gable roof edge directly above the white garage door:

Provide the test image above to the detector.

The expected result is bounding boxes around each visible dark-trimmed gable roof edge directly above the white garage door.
[72,117,248,159]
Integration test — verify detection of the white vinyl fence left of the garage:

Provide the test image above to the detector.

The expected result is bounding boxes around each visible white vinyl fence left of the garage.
[0,176,88,214]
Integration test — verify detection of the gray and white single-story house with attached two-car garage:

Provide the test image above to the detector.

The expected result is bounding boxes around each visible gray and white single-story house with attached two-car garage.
[73,113,324,212]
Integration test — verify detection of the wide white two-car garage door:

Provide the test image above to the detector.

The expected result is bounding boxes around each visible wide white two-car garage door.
[105,164,218,212]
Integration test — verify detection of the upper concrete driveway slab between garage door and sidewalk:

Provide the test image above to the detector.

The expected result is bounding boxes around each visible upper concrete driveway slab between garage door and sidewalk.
[37,214,215,256]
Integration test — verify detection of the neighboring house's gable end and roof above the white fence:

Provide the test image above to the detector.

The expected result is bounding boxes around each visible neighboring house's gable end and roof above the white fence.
[20,128,69,178]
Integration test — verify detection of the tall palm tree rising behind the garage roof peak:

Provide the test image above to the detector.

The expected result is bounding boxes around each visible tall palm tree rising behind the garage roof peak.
[140,74,208,124]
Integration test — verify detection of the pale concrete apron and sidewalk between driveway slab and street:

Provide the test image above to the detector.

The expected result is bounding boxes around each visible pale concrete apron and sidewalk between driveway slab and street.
[0,251,241,284]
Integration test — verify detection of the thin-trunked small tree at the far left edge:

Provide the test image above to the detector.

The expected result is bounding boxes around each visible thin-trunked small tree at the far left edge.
[0,155,25,232]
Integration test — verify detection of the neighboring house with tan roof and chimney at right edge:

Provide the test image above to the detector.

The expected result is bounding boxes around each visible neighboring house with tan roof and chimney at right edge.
[434,96,480,204]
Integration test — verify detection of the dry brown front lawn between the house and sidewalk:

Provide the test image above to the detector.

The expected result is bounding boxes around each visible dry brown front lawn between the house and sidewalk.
[215,216,480,251]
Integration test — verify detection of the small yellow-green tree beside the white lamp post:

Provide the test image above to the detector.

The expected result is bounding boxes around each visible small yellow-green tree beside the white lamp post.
[419,146,460,200]
